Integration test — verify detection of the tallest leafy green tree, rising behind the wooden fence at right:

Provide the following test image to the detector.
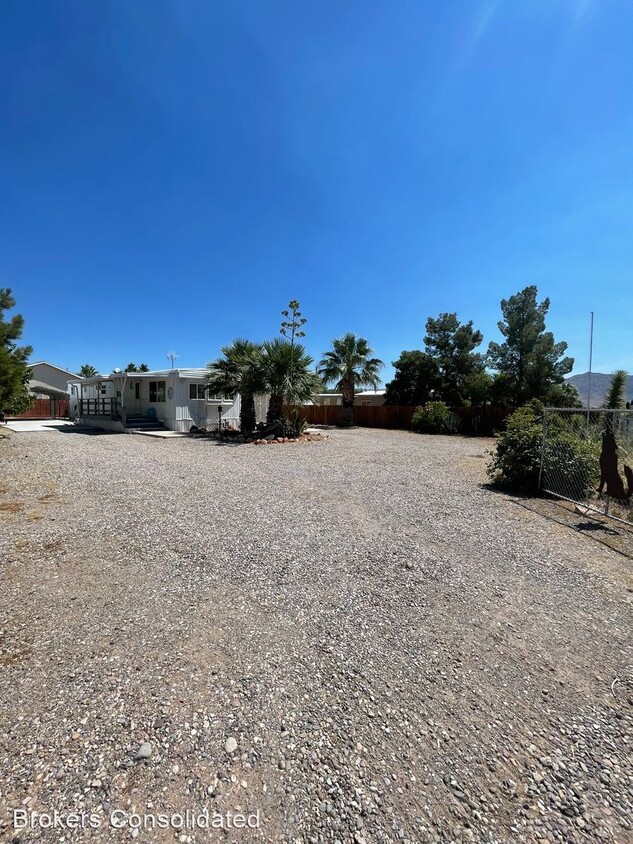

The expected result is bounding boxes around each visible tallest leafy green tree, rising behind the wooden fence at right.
[488,285,574,405]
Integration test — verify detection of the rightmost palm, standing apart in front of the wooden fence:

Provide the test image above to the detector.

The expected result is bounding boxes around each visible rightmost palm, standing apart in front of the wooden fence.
[318,331,384,425]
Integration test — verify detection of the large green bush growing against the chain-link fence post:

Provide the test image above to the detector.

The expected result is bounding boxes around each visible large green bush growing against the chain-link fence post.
[487,402,600,495]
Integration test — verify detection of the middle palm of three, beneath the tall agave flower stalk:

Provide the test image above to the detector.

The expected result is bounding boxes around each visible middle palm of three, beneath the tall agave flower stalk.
[262,340,316,425]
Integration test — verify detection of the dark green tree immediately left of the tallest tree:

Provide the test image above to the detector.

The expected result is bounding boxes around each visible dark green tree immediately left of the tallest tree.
[424,313,484,406]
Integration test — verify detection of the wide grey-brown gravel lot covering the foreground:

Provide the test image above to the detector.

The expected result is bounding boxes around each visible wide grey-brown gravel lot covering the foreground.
[0,430,633,844]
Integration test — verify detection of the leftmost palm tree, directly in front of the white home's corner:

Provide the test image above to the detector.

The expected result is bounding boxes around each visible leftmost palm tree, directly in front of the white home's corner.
[207,338,266,436]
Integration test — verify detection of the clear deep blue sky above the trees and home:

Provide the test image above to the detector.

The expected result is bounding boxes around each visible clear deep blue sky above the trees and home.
[0,0,633,378]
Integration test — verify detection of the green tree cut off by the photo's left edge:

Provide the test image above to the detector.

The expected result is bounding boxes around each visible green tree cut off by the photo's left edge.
[0,288,33,413]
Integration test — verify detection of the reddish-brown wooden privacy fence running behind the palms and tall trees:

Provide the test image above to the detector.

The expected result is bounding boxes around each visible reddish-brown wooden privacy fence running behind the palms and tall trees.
[287,404,513,436]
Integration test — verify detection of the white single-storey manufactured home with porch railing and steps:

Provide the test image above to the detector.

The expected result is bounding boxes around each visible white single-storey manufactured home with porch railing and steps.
[68,369,240,433]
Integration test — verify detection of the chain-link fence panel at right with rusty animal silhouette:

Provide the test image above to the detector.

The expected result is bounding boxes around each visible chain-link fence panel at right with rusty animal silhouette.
[540,407,633,524]
